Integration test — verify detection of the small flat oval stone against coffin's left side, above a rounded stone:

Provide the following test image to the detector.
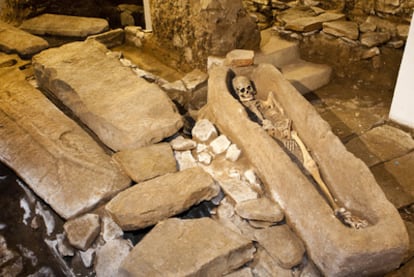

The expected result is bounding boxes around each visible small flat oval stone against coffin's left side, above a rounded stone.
[235,198,285,222]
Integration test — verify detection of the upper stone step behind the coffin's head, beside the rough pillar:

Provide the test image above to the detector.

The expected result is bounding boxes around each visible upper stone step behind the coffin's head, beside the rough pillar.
[254,29,300,67]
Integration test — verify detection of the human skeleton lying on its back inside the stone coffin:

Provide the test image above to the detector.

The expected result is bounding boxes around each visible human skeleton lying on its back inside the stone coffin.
[232,75,368,229]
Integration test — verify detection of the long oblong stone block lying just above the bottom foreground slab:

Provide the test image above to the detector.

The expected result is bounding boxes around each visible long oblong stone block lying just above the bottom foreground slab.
[106,167,219,230]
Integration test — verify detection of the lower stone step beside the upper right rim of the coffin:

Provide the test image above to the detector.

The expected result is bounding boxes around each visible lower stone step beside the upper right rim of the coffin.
[281,61,332,94]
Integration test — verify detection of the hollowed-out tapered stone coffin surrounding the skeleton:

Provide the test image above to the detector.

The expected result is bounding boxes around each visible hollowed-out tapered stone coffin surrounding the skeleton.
[204,64,408,276]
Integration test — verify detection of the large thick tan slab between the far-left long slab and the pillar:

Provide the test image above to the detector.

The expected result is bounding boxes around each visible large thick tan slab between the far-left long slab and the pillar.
[33,40,183,150]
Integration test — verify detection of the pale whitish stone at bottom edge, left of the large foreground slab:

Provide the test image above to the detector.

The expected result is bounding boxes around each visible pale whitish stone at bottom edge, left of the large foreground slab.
[95,239,132,277]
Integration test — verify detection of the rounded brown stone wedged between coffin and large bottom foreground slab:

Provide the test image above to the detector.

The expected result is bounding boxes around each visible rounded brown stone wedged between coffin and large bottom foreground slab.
[255,225,305,269]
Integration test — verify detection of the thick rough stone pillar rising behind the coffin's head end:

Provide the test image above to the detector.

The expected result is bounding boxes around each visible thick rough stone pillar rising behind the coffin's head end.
[150,0,260,68]
